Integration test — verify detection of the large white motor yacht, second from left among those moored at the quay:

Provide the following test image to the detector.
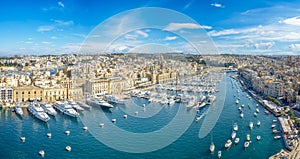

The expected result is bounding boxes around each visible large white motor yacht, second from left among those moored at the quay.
[27,103,50,122]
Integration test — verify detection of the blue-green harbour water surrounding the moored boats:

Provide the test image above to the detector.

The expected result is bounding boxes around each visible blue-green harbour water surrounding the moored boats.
[0,73,283,159]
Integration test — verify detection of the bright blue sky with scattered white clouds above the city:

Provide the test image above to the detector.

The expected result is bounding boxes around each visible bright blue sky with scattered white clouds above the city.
[0,0,300,56]
